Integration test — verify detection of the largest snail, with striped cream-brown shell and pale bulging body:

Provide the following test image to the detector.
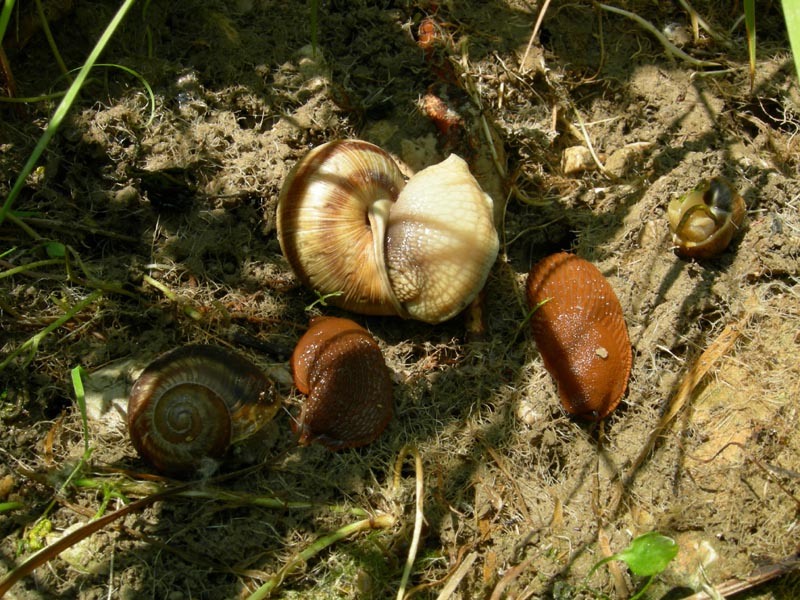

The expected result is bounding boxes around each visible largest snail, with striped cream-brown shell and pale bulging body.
[277,140,499,323]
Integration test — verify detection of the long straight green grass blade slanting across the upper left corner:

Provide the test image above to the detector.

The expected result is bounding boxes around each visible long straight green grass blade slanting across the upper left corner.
[0,0,136,224]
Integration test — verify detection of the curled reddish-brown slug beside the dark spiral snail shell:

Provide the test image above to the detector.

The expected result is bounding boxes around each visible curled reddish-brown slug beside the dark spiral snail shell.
[291,317,392,450]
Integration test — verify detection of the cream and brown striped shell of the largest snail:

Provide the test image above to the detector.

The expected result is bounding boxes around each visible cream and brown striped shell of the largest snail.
[277,141,405,315]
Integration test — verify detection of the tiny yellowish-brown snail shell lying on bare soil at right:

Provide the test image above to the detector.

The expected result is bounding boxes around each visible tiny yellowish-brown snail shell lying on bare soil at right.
[667,177,745,259]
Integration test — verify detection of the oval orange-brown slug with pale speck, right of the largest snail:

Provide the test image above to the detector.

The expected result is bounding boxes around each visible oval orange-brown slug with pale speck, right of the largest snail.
[526,252,632,420]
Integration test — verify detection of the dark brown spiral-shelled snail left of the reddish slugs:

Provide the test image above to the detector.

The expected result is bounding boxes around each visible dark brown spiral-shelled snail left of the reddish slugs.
[128,344,280,477]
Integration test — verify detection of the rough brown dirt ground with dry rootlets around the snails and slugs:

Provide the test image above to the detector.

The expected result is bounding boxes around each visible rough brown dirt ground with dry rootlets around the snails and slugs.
[0,0,800,600]
